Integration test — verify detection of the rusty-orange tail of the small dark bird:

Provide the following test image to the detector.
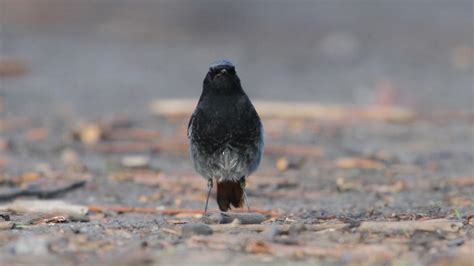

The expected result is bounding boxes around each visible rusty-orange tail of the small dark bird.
[217,181,244,212]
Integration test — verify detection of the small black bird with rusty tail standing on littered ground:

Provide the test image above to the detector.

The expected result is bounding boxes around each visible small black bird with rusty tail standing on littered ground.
[188,60,263,212]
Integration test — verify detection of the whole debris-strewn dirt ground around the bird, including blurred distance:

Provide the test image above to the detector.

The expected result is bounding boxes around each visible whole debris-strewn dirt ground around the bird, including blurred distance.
[0,0,474,265]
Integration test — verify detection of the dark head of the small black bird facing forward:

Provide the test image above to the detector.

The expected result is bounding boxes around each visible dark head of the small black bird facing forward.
[204,60,242,93]
